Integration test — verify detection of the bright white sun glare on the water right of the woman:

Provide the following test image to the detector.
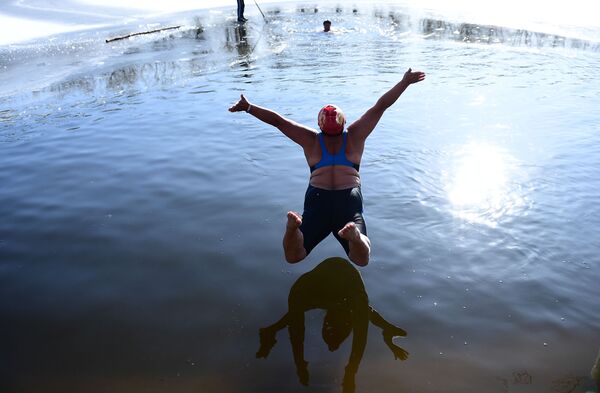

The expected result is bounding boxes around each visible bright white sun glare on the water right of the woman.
[445,143,525,227]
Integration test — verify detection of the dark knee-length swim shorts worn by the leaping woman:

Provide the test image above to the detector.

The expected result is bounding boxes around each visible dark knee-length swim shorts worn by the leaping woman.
[300,185,367,255]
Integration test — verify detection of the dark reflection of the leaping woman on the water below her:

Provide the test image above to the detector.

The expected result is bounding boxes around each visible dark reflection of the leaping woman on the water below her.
[256,257,408,393]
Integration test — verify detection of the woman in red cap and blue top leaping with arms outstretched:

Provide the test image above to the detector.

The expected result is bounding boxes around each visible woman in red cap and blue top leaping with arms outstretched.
[229,68,425,266]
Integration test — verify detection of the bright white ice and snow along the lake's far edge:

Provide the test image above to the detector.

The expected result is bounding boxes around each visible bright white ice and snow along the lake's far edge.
[0,0,600,47]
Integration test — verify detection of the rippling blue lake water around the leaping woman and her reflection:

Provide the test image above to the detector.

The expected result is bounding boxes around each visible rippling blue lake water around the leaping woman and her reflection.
[0,3,600,393]
